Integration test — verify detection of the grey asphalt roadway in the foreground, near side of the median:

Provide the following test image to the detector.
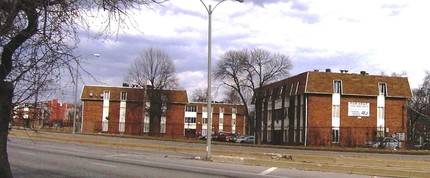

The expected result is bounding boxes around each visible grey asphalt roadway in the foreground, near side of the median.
[8,136,368,178]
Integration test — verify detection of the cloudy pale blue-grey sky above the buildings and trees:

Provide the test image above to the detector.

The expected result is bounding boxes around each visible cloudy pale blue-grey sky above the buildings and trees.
[63,0,430,102]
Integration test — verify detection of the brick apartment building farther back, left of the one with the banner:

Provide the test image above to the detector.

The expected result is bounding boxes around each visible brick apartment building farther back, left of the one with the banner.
[81,85,245,138]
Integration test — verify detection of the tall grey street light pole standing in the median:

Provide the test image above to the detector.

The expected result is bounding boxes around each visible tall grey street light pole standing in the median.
[200,0,244,159]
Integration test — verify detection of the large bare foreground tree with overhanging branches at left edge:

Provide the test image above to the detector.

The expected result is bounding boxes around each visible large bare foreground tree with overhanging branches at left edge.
[0,0,158,178]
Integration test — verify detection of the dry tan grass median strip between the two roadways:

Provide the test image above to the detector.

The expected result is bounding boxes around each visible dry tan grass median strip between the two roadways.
[10,130,430,177]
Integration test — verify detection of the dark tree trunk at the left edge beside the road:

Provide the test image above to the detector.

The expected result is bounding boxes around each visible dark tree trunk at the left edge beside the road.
[0,81,13,178]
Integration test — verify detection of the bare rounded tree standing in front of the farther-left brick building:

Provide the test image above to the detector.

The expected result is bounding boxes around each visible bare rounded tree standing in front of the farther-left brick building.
[126,47,178,135]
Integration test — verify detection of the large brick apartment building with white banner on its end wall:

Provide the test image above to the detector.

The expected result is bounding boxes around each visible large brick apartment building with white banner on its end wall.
[256,69,412,146]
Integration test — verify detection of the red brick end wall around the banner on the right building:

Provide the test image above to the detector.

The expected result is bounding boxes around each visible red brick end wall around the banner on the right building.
[307,95,407,146]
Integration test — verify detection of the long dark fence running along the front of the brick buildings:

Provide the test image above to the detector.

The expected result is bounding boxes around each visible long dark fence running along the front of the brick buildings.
[13,120,410,147]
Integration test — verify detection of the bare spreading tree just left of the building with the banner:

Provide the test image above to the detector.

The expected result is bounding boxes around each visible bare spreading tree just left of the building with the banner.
[214,48,292,144]
